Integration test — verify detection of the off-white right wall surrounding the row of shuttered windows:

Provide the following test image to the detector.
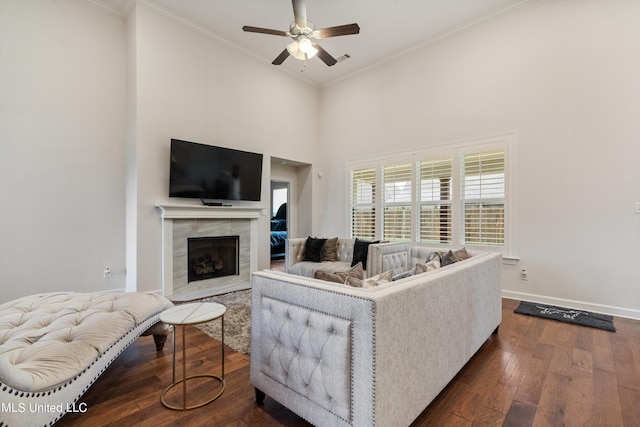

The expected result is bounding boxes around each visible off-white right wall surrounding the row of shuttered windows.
[318,0,640,318]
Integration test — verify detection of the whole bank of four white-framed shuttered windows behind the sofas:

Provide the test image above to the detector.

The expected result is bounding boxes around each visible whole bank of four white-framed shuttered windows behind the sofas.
[347,135,514,256]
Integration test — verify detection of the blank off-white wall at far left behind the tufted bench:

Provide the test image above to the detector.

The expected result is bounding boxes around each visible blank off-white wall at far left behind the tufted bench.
[0,0,125,302]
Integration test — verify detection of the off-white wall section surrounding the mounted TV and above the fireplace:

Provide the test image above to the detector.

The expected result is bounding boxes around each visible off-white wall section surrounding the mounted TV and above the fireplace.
[129,4,319,290]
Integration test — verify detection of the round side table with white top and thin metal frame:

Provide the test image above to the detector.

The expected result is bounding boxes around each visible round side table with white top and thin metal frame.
[160,302,227,411]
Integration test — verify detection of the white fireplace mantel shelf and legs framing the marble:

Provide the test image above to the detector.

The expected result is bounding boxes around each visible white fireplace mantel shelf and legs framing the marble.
[156,204,265,301]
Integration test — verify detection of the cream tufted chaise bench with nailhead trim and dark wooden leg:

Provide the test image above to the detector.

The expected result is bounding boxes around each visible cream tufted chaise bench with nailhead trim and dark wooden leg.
[0,292,173,427]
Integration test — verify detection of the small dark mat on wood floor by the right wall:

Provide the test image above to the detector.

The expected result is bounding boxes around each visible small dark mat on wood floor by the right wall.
[513,301,616,332]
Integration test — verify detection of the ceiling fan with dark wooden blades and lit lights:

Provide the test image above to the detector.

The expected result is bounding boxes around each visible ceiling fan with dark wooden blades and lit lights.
[242,0,360,67]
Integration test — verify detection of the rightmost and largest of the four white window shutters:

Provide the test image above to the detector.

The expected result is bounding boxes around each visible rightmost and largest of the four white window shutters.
[461,150,505,246]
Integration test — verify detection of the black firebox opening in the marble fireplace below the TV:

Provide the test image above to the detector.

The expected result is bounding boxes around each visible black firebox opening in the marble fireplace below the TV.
[187,236,240,282]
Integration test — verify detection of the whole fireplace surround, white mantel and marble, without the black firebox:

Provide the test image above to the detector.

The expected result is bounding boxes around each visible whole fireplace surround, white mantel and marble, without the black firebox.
[156,205,264,301]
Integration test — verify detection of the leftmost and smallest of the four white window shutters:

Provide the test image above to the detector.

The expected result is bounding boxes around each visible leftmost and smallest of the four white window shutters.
[350,168,376,239]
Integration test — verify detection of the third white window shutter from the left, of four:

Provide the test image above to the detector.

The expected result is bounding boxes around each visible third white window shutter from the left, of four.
[418,158,452,243]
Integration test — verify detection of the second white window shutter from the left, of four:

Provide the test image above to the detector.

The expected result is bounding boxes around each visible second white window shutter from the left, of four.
[382,163,413,241]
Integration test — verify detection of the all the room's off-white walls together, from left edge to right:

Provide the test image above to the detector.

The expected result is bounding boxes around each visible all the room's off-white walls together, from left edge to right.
[0,0,640,318]
